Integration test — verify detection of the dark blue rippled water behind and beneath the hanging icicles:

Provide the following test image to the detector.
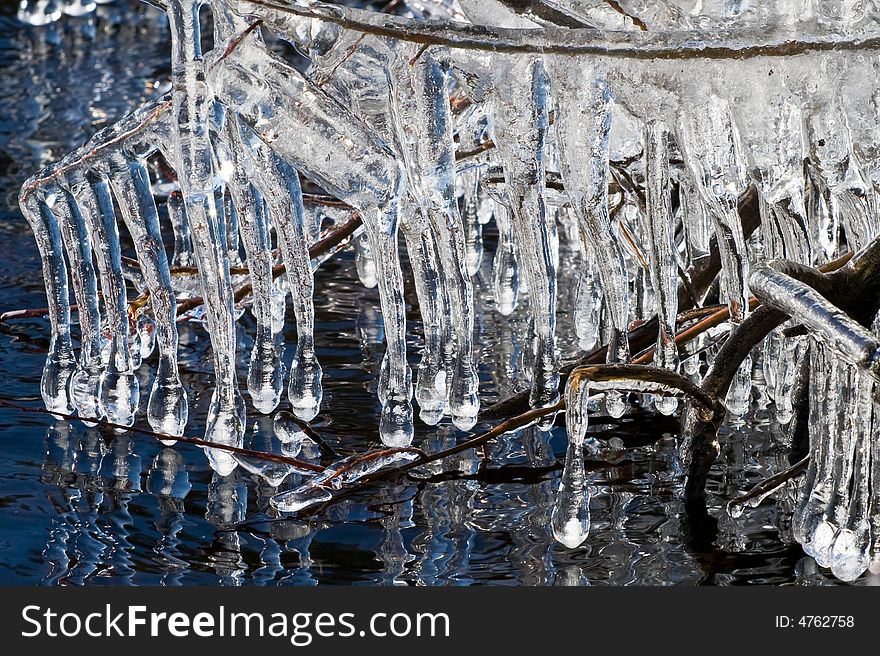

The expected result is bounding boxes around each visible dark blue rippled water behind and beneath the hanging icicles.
[0,0,869,585]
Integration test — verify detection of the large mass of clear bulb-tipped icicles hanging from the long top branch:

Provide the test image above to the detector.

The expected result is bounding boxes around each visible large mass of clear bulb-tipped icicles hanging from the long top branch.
[20,0,880,580]
